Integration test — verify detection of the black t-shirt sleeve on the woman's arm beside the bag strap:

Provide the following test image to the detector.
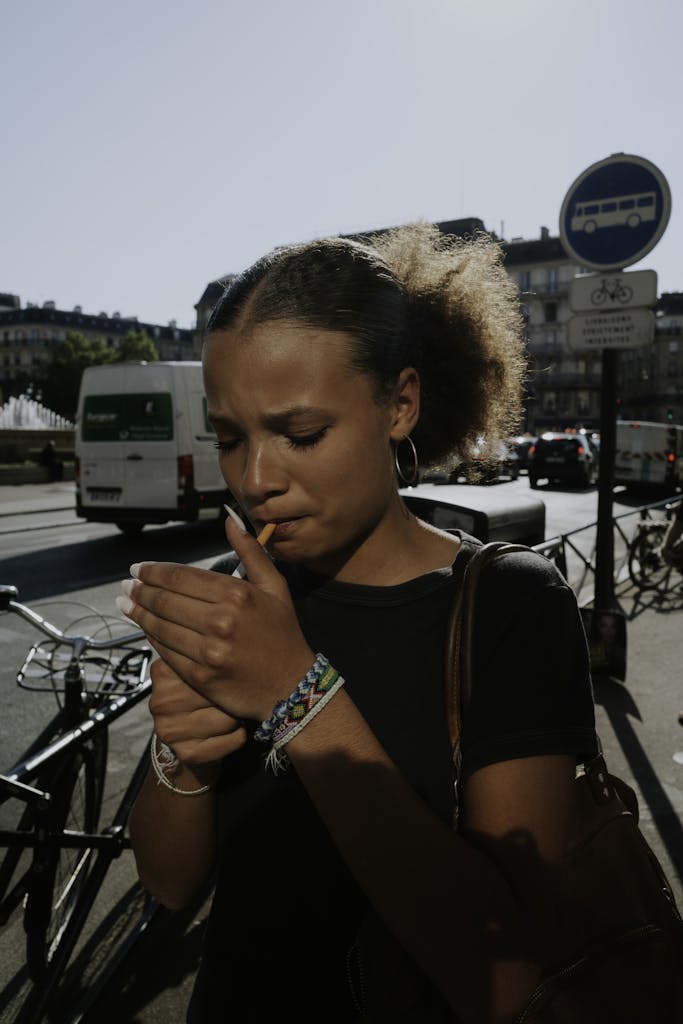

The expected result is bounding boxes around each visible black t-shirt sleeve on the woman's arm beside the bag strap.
[462,552,597,780]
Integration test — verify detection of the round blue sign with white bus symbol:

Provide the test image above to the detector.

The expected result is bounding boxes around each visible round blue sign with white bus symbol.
[560,153,671,270]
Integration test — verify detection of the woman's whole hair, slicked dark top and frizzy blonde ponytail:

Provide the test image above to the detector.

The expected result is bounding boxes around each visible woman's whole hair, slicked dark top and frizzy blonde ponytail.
[206,222,526,469]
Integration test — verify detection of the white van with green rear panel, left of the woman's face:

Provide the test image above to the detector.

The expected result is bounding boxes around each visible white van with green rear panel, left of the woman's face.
[76,361,227,534]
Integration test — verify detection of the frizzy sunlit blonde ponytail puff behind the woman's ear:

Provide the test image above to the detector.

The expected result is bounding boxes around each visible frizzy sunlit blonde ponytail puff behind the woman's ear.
[372,223,526,466]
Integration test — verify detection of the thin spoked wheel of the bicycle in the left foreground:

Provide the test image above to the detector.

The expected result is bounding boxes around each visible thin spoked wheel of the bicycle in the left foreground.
[24,731,108,979]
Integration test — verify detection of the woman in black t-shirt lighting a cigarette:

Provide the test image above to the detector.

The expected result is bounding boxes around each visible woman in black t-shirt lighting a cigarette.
[119,224,596,1024]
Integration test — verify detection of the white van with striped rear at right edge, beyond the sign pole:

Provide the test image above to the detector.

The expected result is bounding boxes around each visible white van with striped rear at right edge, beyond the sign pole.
[614,420,683,493]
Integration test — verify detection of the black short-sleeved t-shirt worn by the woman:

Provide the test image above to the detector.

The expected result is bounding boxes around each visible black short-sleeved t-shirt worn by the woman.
[187,534,597,1024]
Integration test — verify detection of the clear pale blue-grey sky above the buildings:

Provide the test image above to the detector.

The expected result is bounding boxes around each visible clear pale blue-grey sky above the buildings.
[0,0,683,328]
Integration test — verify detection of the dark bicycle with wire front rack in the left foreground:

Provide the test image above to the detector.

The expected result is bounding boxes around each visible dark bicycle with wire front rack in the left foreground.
[0,586,159,1024]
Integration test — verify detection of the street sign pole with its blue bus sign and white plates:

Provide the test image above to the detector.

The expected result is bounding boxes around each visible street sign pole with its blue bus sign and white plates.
[560,153,671,680]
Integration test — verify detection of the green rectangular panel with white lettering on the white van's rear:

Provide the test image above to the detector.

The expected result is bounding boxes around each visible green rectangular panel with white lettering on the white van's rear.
[82,391,173,441]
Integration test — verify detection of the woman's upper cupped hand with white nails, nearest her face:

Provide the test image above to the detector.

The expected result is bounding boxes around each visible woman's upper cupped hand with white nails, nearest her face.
[118,520,315,729]
